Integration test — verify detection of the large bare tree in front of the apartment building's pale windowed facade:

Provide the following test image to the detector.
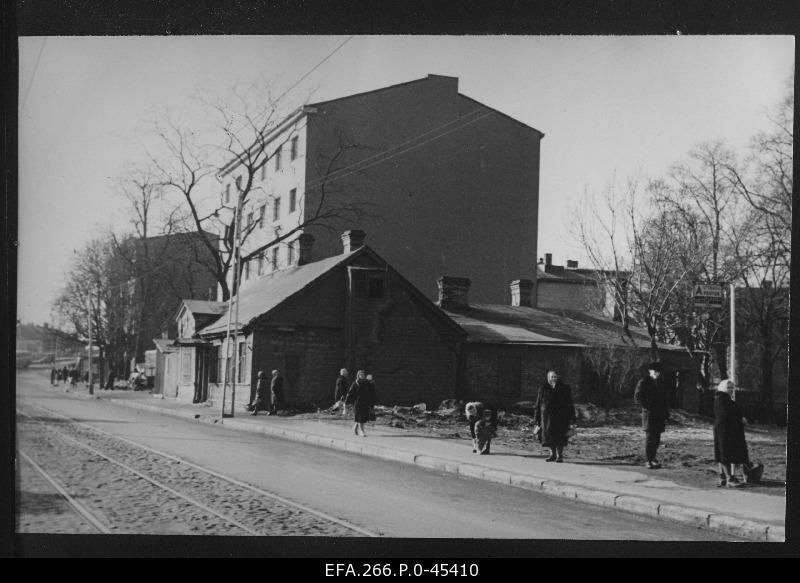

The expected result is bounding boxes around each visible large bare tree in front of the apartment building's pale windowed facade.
[149,86,376,301]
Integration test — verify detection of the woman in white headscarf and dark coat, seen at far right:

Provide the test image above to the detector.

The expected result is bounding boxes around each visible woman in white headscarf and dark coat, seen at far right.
[714,379,750,488]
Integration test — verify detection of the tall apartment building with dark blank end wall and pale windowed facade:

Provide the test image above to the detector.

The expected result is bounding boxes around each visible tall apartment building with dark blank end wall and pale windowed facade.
[220,75,544,302]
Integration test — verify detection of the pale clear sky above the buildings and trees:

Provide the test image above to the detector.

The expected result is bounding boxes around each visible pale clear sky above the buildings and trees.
[17,35,794,324]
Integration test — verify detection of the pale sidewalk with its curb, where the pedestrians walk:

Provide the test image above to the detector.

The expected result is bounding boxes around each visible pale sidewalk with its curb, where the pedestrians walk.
[59,387,786,542]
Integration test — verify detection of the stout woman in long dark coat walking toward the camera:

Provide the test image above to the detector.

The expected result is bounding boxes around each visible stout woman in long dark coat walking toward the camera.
[534,369,575,463]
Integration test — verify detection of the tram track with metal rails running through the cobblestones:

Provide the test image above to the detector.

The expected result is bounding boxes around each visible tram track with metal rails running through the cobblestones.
[17,401,379,537]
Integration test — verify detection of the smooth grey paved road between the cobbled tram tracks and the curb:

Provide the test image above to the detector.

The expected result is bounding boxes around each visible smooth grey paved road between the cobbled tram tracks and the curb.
[17,370,735,541]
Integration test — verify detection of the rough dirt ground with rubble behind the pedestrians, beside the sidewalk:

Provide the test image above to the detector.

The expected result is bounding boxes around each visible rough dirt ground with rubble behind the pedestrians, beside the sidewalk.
[290,400,786,496]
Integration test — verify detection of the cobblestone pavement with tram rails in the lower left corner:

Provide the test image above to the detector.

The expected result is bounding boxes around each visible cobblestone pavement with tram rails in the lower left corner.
[17,406,363,536]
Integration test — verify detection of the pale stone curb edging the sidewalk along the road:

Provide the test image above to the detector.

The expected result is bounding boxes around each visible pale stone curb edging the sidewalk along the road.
[69,393,786,543]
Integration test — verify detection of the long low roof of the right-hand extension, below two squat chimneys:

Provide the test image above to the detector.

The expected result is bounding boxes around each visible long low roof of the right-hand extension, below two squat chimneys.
[445,304,680,350]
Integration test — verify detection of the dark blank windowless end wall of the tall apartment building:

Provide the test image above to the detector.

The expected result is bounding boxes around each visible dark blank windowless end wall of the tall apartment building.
[306,76,541,303]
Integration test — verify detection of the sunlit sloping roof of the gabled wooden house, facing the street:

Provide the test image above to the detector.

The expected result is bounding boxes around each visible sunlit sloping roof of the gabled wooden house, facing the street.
[199,247,366,336]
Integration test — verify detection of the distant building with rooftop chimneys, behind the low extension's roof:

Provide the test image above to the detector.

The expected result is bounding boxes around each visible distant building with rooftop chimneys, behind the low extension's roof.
[534,253,626,320]
